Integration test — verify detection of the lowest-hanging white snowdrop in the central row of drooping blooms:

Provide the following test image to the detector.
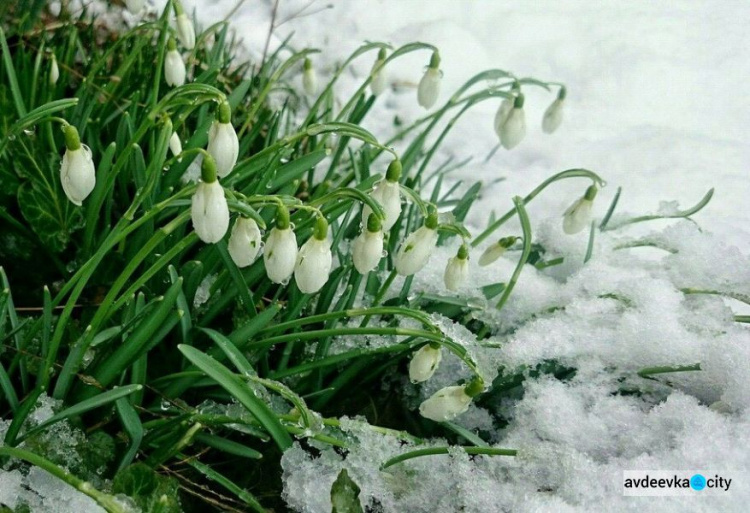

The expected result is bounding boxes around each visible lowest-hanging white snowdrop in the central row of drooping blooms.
[294,216,333,294]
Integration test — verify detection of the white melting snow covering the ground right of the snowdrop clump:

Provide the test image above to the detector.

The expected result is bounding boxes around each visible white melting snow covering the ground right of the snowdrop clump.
[154,0,750,512]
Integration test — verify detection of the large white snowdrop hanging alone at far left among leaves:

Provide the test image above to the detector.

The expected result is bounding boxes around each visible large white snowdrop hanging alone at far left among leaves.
[60,125,96,207]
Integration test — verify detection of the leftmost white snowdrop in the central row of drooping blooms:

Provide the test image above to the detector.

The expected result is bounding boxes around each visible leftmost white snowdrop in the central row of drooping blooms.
[190,155,229,244]
